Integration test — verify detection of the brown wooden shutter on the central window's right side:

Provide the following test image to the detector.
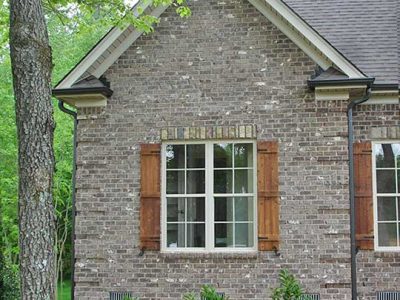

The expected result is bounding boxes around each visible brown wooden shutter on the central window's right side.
[257,141,279,251]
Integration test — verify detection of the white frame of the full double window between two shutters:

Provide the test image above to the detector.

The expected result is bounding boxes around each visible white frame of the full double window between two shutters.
[160,139,258,253]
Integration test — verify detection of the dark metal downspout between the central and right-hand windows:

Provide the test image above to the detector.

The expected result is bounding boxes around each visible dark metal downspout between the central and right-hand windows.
[347,89,371,300]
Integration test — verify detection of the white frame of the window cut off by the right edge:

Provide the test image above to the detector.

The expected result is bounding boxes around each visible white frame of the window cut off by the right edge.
[371,140,400,252]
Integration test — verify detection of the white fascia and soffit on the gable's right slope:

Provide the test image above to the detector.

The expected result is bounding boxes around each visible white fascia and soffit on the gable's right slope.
[249,0,365,78]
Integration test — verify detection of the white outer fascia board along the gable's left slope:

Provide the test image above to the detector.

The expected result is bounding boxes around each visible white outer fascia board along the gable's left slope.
[55,1,153,89]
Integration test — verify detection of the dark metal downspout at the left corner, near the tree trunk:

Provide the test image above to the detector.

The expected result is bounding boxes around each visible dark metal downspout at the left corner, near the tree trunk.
[58,100,78,300]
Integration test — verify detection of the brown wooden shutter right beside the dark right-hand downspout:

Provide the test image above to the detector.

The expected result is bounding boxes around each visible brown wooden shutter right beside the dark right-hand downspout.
[353,142,374,250]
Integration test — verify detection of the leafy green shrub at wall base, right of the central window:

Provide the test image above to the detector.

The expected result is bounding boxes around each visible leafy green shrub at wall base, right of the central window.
[272,269,305,300]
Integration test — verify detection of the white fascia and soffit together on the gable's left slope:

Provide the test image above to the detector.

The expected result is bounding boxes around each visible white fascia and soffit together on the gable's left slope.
[55,1,168,89]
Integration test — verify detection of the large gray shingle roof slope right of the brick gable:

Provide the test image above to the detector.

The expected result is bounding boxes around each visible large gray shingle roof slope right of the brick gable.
[284,0,400,84]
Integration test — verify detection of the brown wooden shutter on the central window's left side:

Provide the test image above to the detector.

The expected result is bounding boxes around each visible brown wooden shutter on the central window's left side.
[140,144,161,250]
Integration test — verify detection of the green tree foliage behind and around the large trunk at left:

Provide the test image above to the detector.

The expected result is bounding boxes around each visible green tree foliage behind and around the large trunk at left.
[0,0,191,300]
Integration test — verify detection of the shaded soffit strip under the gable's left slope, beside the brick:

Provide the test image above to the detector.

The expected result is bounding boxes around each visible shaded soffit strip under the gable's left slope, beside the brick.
[92,5,167,78]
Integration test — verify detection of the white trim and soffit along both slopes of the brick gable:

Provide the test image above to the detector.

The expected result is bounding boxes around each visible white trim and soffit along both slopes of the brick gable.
[55,0,366,89]
